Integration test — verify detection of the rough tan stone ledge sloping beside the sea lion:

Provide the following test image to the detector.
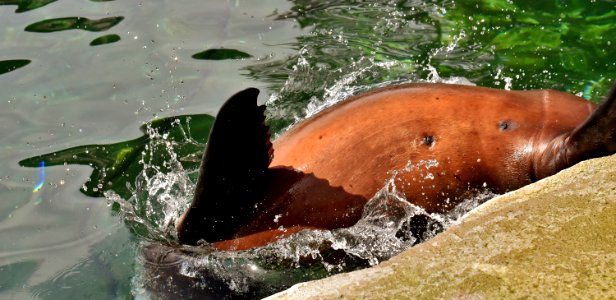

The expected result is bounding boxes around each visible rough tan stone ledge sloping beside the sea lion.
[271,155,616,299]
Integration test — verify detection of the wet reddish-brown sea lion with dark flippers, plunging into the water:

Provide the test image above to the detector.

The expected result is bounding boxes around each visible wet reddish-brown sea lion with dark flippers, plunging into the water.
[177,83,616,250]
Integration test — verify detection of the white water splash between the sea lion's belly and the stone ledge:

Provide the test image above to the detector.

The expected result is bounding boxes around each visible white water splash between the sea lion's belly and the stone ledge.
[134,168,492,298]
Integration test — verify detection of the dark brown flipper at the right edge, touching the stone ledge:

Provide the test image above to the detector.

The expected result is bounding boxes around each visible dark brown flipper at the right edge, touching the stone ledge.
[535,82,616,179]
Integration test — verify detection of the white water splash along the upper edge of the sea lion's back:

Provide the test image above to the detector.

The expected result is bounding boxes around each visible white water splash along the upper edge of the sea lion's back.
[266,24,475,131]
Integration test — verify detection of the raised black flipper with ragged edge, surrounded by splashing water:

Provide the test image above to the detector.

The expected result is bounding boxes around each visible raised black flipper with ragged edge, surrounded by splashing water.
[177,88,273,245]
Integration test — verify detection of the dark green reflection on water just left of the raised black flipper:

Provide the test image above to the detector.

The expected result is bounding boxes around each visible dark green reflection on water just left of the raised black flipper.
[19,115,214,199]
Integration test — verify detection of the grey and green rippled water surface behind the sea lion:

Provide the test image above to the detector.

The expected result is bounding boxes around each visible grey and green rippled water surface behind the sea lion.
[0,0,616,299]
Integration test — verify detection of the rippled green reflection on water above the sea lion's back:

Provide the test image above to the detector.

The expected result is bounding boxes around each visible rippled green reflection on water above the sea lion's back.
[247,0,616,129]
